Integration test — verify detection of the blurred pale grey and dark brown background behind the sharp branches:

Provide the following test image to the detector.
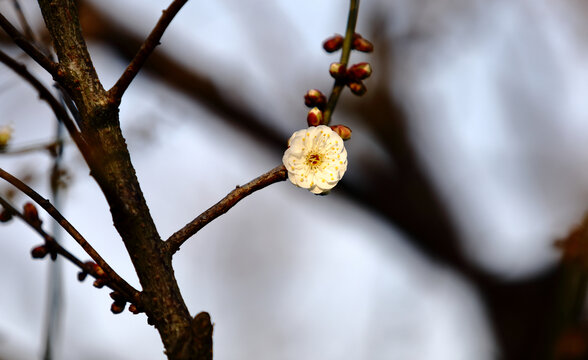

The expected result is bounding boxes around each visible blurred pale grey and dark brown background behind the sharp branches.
[0,0,588,360]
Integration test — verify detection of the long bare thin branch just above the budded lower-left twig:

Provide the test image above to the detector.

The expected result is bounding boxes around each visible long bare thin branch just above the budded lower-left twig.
[0,168,139,298]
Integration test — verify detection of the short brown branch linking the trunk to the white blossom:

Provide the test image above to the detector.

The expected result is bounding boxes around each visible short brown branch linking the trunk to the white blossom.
[164,165,288,254]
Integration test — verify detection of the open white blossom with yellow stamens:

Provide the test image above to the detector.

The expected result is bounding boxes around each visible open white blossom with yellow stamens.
[282,125,347,194]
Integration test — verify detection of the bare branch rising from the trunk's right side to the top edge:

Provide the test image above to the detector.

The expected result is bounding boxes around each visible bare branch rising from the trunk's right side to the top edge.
[109,0,188,102]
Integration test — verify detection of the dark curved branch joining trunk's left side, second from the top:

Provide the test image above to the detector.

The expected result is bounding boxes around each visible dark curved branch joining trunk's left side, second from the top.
[0,48,87,154]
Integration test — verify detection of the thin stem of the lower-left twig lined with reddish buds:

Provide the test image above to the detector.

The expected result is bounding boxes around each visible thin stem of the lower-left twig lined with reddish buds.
[0,196,138,302]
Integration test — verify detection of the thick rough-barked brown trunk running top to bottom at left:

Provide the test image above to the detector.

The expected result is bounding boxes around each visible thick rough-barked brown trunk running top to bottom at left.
[39,0,212,359]
